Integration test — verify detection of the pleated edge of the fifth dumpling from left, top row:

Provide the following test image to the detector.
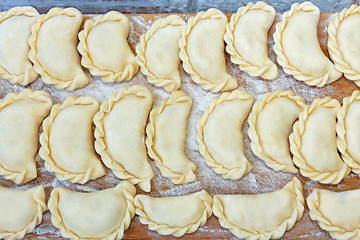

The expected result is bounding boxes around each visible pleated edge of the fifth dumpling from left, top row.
[178,8,238,92]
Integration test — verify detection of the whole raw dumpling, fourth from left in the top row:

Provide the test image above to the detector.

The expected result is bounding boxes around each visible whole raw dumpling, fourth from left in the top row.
[136,15,185,92]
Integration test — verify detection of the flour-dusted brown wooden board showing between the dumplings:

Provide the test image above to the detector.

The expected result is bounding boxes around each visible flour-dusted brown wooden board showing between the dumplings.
[0,13,360,240]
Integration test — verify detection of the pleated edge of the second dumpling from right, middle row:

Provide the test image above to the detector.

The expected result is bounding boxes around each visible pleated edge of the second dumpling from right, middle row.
[289,97,351,184]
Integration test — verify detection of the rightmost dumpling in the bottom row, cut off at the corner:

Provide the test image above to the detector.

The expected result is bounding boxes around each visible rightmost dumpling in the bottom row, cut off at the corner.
[306,189,360,239]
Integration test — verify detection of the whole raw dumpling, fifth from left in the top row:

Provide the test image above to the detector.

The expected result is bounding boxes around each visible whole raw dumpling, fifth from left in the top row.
[179,8,238,92]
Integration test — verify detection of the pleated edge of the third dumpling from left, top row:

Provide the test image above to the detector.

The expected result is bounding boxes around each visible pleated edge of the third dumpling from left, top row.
[77,11,139,82]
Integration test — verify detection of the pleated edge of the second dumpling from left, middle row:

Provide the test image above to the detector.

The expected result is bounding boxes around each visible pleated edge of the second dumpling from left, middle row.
[39,96,105,184]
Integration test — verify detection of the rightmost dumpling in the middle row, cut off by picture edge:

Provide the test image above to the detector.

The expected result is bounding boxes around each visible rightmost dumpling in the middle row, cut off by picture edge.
[336,90,360,175]
